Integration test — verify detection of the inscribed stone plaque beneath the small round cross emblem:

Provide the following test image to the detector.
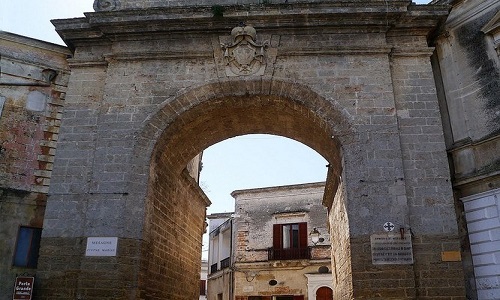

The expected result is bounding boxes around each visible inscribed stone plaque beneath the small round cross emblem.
[370,233,413,265]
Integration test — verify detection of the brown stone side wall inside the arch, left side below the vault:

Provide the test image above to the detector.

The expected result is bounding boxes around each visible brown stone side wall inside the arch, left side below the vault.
[139,171,208,299]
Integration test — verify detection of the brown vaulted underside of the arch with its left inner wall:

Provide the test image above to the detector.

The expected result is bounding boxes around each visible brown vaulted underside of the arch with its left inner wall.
[139,83,349,299]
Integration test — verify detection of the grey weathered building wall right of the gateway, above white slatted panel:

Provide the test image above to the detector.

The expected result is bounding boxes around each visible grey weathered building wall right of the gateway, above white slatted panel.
[432,0,500,299]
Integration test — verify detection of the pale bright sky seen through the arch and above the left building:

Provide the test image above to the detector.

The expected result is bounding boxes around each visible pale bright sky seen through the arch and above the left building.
[0,0,428,256]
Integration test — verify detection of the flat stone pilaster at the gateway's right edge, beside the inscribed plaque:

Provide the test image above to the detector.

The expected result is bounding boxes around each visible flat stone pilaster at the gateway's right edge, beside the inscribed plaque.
[389,39,465,299]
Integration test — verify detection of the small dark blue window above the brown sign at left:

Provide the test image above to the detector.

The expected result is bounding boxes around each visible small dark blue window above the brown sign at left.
[13,226,42,268]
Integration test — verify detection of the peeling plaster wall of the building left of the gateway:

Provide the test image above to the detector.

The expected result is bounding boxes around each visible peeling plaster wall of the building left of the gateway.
[0,32,70,300]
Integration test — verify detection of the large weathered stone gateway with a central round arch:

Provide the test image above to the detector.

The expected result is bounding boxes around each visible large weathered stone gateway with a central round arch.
[37,0,464,299]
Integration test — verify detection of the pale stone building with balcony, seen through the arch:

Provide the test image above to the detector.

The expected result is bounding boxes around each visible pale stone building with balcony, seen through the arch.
[207,183,336,300]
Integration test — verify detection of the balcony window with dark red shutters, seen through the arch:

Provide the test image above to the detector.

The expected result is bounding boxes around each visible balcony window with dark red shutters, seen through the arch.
[269,222,310,260]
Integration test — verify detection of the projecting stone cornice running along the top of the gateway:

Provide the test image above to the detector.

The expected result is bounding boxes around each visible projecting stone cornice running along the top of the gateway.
[52,1,448,48]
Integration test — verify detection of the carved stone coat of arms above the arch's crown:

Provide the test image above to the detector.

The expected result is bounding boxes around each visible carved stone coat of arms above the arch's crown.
[221,26,268,76]
